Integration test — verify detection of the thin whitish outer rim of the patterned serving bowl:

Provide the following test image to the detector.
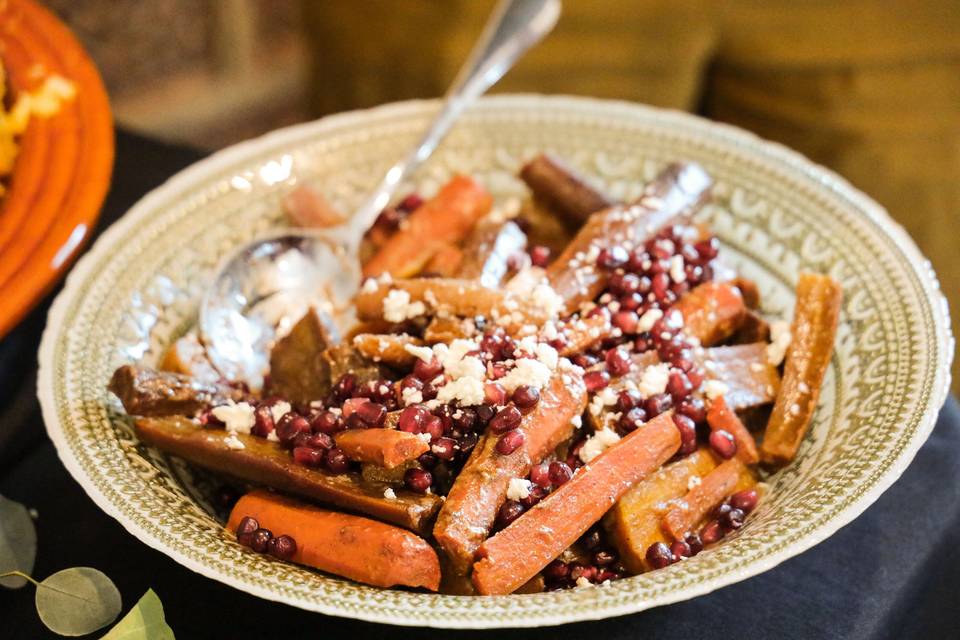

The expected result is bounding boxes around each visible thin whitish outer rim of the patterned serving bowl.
[37,94,954,628]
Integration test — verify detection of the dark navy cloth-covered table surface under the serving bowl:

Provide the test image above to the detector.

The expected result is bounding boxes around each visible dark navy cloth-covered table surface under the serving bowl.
[0,132,960,640]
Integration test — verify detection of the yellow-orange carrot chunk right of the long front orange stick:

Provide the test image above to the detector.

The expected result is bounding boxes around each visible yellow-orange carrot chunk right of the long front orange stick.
[603,447,717,573]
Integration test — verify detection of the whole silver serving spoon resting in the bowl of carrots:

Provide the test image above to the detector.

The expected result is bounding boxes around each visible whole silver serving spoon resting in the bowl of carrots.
[200,0,560,388]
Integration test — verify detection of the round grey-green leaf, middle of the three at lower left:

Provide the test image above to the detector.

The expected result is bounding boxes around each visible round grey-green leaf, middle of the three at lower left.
[36,567,122,636]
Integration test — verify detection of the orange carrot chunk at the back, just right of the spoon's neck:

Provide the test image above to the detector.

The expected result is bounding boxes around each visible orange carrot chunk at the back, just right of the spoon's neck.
[363,176,493,278]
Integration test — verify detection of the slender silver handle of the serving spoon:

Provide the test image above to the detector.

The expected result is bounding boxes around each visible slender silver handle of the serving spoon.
[350,0,560,242]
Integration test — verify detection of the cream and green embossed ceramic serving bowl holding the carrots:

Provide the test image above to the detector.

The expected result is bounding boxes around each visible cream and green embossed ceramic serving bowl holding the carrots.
[39,95,953,628]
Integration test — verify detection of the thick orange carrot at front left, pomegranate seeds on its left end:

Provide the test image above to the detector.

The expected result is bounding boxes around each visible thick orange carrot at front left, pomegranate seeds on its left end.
[227,490,440,591]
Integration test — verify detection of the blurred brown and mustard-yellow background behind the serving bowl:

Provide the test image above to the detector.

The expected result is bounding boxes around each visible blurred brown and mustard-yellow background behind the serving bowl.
[47,0,960,389]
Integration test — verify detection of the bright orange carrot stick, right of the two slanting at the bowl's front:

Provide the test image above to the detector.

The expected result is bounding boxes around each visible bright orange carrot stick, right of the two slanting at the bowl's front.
[472,414,680,595]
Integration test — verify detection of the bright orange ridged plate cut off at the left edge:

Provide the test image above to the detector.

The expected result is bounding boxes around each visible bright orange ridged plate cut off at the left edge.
[0,0,113,338]
